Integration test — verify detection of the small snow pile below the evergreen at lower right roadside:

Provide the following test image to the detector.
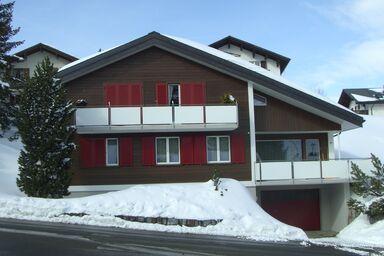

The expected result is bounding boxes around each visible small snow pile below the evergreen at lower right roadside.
[337,214,384,247]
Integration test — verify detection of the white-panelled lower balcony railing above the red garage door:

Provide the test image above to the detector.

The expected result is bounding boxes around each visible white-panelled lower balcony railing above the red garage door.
[255,159,373,186]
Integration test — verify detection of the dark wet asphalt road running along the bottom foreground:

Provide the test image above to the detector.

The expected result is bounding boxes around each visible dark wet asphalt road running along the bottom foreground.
[0,219,372,256]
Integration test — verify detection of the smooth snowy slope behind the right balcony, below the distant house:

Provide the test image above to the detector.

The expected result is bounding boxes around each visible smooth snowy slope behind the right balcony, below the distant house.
[335,115,384,161]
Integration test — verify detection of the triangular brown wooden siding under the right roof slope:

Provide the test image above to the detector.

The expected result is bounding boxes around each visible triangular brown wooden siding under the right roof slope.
[255,91,341,132]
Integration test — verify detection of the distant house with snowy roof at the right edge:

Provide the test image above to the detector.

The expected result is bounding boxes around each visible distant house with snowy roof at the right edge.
[339,88,384,116]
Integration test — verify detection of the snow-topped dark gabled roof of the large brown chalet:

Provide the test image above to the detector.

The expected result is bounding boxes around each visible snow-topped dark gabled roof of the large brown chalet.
[58,32,363,129]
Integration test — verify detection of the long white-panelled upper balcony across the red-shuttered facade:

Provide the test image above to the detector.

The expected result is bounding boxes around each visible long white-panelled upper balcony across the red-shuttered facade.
[75,105,238,134]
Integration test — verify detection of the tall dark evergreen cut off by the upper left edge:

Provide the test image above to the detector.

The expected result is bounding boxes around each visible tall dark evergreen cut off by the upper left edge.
[0,2,23,136]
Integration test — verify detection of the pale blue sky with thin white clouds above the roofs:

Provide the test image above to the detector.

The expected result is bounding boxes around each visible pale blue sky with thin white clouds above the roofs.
[8,0,384,101]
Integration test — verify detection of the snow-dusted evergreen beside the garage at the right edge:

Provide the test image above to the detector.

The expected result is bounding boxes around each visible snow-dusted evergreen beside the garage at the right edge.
[348,154,384,223]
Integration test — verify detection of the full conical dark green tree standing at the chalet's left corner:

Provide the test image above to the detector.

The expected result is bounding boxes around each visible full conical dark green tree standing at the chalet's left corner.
[16,58,75,198]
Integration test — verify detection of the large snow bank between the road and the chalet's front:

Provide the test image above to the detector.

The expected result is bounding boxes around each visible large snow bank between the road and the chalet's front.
[0,179,306,241]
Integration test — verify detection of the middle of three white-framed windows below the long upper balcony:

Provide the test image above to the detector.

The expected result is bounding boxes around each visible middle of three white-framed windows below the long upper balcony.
[156,137,180,164]
